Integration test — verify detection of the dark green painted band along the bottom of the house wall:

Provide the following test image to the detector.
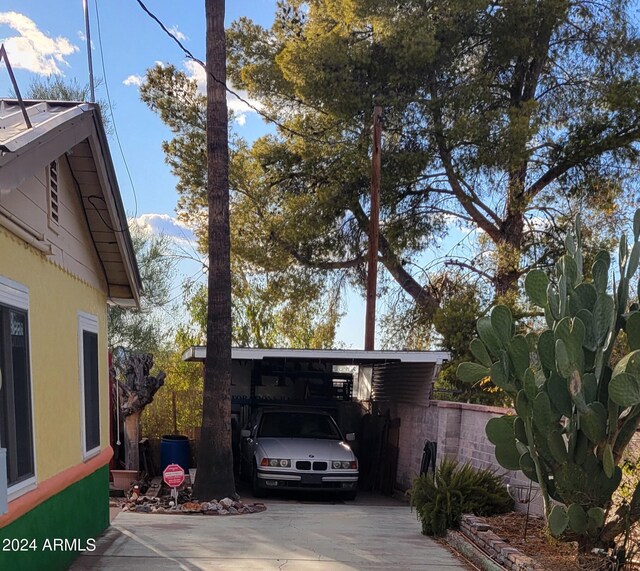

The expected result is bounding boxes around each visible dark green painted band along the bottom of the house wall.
[0,466,109,571]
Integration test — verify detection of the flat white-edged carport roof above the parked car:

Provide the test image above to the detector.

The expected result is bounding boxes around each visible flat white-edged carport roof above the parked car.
[182,346,449,365]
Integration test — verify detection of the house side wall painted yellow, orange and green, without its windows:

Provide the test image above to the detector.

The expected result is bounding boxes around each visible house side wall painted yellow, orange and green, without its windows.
[0,228,111,569]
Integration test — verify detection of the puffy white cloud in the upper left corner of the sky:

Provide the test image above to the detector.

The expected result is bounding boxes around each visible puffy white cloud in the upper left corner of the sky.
[0,12,78,75]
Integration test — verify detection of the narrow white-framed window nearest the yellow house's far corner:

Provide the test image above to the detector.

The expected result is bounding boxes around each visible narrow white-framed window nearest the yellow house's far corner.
[78,312,100,458]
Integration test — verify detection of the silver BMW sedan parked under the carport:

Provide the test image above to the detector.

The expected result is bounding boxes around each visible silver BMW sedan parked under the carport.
[241,409,358,499]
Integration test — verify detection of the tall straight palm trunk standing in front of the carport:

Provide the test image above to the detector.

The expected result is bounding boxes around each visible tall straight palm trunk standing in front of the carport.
[194,0,235,500]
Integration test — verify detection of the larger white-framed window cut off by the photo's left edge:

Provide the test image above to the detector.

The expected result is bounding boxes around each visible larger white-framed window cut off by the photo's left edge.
[0,276,36,495]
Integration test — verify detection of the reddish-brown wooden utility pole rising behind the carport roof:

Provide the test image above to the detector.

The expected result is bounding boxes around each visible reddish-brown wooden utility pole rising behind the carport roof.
[364,105,382,351]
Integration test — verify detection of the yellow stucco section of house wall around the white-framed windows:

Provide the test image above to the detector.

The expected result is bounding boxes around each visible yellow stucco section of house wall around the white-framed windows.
[0,228,109,482]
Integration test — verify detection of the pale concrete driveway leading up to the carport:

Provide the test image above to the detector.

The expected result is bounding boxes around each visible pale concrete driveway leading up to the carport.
[72,499,468,571]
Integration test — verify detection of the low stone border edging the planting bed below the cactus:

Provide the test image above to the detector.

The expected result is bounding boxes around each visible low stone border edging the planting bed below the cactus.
[460,514,545,571]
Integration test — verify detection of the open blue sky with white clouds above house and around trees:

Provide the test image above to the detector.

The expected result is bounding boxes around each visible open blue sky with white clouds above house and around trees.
[0,0,376,348]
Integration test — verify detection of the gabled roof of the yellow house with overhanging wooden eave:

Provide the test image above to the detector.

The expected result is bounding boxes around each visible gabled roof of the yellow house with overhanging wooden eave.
[0,99,142,305]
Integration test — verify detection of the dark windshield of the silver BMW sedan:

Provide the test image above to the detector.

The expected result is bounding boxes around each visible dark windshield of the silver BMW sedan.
[258,412,342,440]
